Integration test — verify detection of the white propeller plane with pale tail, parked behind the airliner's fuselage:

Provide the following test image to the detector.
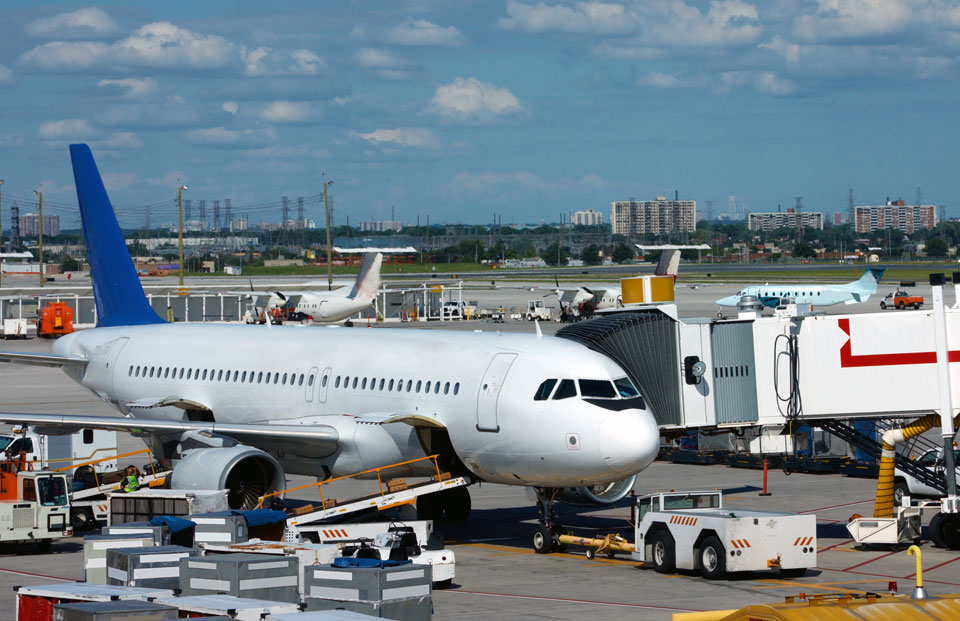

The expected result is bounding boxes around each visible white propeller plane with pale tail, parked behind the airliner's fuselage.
[240,252,383,322]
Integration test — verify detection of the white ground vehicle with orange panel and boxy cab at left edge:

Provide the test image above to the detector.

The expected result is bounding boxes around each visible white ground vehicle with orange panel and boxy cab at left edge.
[0,460,73,552]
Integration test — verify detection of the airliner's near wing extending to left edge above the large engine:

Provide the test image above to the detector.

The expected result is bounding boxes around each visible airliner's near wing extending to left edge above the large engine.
[0,412,340,457]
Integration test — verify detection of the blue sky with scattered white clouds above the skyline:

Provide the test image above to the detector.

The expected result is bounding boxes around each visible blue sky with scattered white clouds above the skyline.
[0,0,960,230]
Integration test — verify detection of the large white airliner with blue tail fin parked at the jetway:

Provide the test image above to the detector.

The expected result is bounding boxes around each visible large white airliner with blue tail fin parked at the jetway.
[0,145,660,549]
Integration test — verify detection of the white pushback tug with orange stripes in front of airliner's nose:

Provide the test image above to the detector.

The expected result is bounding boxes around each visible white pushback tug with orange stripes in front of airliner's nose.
[631,491,817,579]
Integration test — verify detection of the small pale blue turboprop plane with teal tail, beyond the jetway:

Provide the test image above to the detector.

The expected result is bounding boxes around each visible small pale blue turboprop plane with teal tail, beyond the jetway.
[717,267,884,308]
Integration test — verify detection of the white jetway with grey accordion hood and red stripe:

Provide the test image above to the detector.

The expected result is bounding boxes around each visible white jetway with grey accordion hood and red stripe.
[557,272,960,549]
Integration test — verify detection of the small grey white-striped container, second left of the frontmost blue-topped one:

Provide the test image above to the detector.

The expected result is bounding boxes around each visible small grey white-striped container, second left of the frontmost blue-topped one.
[107,546,195,589]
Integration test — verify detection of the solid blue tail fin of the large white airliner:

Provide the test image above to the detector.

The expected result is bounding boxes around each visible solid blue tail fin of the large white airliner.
[70,144,164,328]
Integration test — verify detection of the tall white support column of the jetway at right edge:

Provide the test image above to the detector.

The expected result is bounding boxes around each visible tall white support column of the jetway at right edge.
[930,272,960,514]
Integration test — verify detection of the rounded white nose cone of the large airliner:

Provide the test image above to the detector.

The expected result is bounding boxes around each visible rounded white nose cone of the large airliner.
[598,410,660,476]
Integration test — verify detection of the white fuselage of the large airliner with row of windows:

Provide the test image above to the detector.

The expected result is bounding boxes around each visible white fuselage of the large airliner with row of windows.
[54,324,659,487]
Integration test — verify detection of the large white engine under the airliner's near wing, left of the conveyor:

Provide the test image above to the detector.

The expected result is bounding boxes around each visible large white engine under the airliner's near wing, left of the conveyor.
[170,444,285,509]
